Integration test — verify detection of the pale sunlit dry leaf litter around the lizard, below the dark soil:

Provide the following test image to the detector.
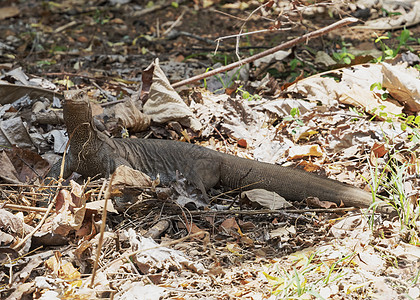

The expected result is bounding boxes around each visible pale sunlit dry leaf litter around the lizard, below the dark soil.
[0,1,420,299]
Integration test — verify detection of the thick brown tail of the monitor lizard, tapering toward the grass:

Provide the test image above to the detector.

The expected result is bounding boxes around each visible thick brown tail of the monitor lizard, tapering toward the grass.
[220,156,378,207]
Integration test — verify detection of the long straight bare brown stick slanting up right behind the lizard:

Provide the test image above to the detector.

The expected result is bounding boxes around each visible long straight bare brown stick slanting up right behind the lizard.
[172,18,358,88]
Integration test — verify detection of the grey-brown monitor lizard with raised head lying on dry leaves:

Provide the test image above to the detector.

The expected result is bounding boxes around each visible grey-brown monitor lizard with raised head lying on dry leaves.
[49,94,390,210]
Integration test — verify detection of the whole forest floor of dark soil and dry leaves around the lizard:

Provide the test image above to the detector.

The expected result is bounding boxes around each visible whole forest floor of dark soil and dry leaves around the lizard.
[0,0,420,299]
